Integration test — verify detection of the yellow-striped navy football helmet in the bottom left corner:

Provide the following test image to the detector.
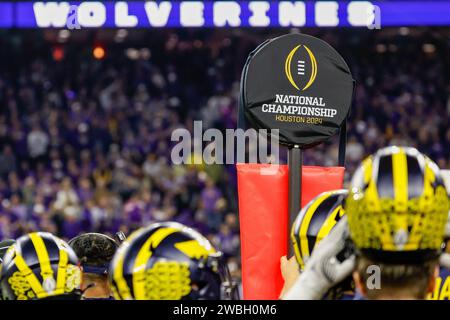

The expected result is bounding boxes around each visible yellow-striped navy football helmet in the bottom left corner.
[0,232,81,300]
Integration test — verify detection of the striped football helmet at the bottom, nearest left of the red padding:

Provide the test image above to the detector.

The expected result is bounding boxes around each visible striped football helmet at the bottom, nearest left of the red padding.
[109,222,237,300]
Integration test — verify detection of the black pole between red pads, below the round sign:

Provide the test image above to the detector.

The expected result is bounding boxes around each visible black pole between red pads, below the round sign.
[287,145,303,258]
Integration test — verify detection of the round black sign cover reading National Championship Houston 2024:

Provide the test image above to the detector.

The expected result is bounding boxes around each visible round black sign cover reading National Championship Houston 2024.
[240,34,354,148]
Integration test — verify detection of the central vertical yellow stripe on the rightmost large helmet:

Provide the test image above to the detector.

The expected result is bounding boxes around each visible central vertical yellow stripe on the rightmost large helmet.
[392,148,408,240]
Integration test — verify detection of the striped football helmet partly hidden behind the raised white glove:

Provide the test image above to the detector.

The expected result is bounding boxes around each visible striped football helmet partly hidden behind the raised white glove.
[291,190,348,269]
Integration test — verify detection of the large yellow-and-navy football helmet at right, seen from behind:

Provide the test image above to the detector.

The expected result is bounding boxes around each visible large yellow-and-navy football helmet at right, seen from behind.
[345,146,449,263]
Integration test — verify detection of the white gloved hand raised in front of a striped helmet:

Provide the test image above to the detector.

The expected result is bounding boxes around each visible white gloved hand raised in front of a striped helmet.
[281,216,355,300]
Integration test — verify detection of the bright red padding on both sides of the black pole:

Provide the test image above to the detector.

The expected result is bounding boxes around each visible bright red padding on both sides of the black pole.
[236,163,344,300]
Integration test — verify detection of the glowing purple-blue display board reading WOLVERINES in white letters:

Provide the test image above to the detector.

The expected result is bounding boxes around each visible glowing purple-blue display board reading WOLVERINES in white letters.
[0,1,450,28]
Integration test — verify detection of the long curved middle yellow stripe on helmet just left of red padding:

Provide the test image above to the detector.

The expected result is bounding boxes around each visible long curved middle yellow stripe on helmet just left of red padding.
[133,228,179,300]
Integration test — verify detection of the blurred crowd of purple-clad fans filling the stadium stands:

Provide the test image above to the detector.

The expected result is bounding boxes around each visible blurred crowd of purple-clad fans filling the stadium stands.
[0,28,450,275]
